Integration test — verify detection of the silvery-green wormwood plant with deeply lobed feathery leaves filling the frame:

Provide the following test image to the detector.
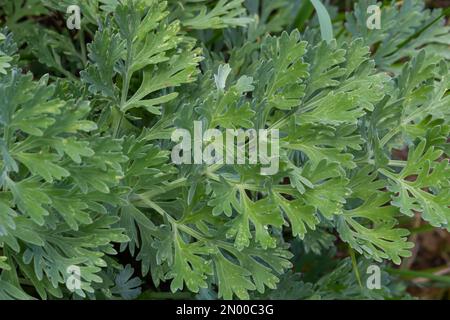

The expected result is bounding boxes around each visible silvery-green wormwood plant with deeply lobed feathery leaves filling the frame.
[0,0,450,299]
